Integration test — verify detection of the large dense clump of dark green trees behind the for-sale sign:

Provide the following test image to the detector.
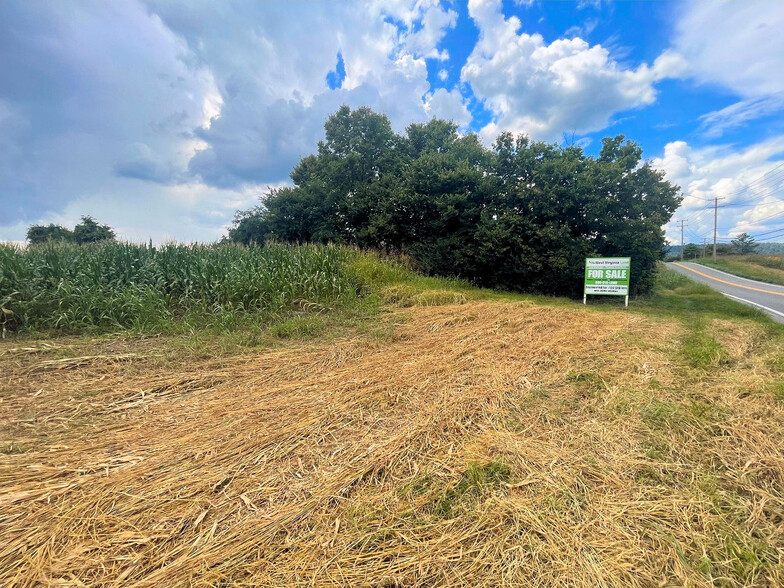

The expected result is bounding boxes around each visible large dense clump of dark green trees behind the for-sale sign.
[229,106,680,296]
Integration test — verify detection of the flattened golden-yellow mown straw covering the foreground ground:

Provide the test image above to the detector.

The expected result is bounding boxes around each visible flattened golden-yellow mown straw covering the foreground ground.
[0,302,784,586]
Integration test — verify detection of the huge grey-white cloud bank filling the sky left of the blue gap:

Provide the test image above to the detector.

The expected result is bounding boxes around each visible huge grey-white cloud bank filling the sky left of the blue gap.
[0,0,460,240]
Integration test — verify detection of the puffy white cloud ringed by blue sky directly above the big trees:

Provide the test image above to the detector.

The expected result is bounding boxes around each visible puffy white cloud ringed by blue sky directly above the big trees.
[461,0,687,140]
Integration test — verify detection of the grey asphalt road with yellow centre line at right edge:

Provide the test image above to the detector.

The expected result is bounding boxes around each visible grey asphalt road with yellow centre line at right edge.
[667,262,784,323]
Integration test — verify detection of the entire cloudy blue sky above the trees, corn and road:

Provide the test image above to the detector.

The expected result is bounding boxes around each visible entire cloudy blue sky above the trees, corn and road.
[0,0,784,243]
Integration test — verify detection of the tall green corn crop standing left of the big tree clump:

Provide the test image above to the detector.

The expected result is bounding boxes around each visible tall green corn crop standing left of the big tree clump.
[0,242,361,334]
